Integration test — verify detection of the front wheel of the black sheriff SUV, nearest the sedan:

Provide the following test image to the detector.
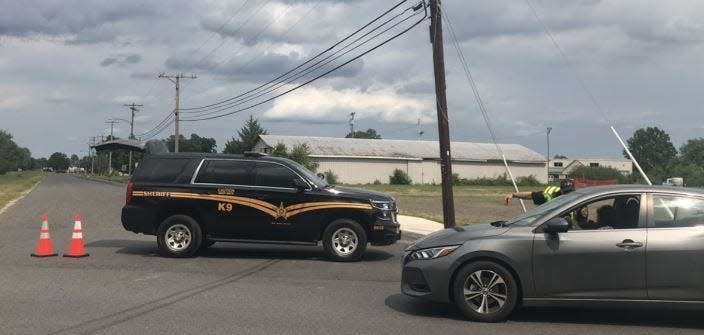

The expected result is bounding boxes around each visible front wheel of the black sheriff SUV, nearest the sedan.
[323,219,367,262]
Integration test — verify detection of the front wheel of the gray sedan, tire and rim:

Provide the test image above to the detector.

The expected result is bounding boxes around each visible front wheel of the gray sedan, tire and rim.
[453,261,518,322]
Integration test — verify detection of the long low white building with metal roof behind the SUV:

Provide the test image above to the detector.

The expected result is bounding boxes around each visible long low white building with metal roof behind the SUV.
[254,135,547,184]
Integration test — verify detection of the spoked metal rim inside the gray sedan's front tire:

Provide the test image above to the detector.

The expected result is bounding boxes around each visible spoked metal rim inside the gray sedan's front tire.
[463,270,508,314]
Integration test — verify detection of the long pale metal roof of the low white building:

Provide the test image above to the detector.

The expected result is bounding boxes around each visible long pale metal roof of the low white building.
[259,135,546,163]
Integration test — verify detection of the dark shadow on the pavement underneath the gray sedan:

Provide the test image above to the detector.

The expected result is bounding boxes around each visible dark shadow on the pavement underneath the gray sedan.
[384,293,704,329]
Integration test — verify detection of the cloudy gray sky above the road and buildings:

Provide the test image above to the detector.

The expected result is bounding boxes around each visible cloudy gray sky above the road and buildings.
[0,0,704,158]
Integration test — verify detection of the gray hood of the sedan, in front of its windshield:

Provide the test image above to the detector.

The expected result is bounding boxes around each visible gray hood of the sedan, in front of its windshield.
[407,223,510,250]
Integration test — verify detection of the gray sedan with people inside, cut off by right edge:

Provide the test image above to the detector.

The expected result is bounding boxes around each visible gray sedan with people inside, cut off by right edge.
[401,185,704,322]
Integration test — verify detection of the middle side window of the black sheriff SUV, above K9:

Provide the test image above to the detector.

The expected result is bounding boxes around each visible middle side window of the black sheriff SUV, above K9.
[195,159,254,185]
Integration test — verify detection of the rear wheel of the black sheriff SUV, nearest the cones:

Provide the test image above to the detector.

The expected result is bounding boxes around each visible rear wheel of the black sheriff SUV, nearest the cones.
[156,215,203,258]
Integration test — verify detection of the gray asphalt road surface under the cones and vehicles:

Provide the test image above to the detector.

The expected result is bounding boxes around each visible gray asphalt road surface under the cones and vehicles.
[0,174,704,335]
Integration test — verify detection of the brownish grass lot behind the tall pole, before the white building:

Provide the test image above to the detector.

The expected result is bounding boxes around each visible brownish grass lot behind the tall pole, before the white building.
[352,185,540,224]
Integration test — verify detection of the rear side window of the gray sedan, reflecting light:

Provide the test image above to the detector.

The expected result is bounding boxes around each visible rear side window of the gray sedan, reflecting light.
[653,194,704,228]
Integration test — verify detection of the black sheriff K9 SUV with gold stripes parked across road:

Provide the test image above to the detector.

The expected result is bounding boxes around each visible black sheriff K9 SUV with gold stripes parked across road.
[122,153,401,261]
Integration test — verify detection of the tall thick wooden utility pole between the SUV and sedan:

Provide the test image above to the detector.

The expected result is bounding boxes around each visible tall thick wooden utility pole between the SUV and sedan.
[430,0,455,228]
